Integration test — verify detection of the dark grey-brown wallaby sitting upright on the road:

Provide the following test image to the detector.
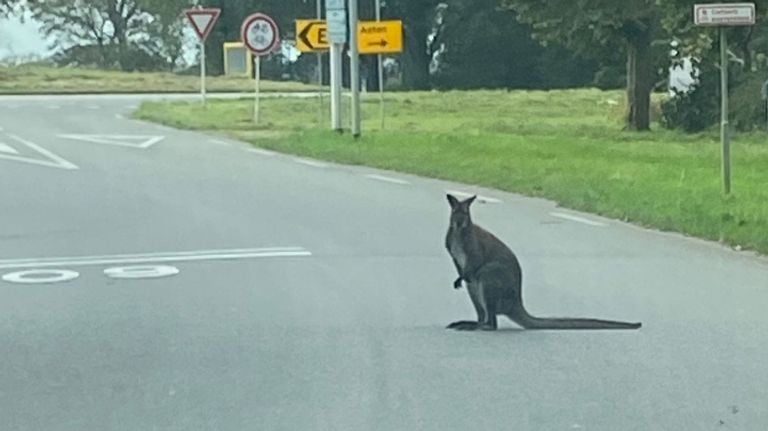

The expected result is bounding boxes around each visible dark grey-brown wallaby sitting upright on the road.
[445,194,641,331]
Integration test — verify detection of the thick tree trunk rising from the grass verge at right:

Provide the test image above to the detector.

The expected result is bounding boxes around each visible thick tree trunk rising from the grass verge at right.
[625,32,653,130]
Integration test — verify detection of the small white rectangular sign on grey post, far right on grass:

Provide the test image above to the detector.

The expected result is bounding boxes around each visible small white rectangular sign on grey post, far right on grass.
[693,3,755,195]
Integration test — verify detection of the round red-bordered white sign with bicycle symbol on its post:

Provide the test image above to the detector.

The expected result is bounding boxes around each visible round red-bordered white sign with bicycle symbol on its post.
[240,13,280,124]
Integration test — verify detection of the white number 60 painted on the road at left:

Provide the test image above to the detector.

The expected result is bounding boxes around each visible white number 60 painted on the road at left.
[1,265,179,284]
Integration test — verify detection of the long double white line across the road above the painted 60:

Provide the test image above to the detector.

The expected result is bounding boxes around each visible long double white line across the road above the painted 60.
[0,247,312,269]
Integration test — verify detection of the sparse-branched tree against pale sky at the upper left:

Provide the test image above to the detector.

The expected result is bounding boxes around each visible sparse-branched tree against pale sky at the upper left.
[27,0,190,70]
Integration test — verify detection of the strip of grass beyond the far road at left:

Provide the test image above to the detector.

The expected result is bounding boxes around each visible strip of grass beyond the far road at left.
[0,64,316,94]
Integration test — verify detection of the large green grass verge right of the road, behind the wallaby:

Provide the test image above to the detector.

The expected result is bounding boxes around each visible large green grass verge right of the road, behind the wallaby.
[135,89,768,253]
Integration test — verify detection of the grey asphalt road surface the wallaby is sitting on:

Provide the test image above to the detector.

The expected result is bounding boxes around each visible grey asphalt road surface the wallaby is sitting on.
[0,96,768,431]
